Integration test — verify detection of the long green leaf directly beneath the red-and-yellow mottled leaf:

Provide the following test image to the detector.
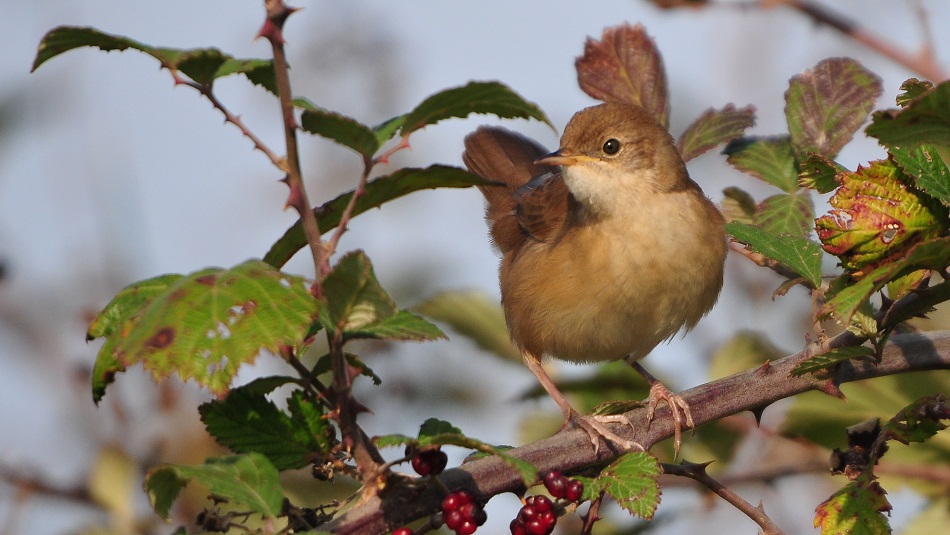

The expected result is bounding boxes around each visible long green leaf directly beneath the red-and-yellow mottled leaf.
[819,238,950,327]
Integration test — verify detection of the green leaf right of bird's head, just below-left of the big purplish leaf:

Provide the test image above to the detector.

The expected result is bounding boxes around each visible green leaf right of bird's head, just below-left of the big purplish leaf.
[722,136,798,193]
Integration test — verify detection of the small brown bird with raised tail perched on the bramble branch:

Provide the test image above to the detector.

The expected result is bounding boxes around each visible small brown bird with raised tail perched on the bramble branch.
[462,103,726,451]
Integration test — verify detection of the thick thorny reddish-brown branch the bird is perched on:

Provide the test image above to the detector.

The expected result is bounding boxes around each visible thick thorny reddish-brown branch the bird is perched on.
[321,331,950,534]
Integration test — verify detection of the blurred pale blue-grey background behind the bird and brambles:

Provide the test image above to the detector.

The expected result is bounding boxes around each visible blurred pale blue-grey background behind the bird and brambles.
[0,0,950,535]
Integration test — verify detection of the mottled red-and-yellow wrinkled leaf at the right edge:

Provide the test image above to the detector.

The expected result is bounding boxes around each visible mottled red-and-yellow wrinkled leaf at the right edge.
[815,160,947,271]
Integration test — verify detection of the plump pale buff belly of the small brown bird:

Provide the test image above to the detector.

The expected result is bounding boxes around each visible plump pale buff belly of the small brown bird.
[501,209,725,362]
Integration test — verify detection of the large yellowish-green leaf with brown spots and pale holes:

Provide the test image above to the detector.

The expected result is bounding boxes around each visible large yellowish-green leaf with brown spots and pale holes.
[113,260,321,395]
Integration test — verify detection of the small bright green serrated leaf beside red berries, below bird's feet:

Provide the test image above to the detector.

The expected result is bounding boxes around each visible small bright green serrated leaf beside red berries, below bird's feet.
[584,451,660,520]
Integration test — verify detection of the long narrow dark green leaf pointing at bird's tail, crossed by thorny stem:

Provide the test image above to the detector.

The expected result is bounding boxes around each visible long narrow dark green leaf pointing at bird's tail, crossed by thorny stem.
[264,165,493,267]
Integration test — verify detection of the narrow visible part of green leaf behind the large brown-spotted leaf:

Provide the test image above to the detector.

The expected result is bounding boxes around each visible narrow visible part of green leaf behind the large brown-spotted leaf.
[86,274,183,404]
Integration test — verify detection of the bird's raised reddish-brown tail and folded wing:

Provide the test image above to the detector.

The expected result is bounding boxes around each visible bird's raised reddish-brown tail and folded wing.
[462,126,570,253]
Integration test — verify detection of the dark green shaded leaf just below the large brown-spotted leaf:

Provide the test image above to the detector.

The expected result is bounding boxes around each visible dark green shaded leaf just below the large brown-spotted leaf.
[198,387,333,470]
